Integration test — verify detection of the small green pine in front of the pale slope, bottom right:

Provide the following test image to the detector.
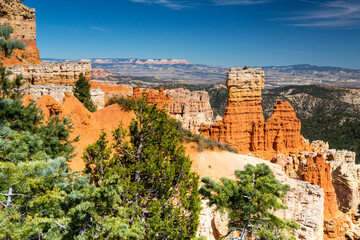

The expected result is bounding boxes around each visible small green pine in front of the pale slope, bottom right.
[200,164,298,240]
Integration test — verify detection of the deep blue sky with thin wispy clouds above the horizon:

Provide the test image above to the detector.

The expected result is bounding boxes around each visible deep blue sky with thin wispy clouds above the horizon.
[24,0,360,69]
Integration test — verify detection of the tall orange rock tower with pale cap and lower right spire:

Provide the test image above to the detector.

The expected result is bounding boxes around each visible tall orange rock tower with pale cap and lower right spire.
[200,68,305,158]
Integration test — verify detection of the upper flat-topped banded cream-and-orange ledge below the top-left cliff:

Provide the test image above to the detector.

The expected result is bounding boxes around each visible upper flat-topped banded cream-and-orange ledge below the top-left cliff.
[8,62,91,85]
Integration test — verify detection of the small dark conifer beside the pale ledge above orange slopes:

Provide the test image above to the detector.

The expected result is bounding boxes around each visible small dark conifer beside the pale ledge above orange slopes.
[73,73,96,112]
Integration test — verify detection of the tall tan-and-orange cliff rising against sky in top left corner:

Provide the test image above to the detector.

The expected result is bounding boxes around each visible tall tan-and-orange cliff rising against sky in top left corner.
[0,0,40,65]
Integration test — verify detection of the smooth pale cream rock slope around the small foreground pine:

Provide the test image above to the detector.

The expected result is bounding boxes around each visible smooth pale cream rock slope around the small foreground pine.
[190,150,324,240]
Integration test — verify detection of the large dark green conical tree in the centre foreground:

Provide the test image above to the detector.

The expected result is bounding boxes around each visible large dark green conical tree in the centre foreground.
[84,101,200,239]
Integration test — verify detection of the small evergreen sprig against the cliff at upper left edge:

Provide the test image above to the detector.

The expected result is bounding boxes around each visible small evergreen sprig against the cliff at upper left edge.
[0,25,26,57]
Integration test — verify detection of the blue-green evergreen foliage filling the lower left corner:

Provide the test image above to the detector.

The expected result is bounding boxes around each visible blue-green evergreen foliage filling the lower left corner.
[0,66,144,240]
